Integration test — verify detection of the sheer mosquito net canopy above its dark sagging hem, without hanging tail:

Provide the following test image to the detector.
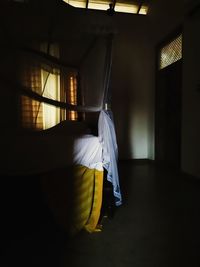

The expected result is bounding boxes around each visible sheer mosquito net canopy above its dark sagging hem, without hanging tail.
[4,1,114,111]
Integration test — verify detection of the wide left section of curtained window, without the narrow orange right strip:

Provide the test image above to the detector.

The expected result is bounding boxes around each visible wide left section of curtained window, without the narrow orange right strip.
[21,69,61,130]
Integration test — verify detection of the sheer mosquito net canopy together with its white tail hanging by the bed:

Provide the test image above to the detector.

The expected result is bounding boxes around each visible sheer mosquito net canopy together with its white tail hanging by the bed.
[1,1,121,205]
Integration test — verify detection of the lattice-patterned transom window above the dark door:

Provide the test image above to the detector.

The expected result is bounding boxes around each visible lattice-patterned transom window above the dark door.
[159,34,182,69]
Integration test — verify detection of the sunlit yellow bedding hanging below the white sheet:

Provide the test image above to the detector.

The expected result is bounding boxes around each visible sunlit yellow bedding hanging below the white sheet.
[70,165,103,234]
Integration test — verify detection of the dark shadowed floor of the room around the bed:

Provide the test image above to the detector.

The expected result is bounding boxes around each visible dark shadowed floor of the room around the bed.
[0,161,200,267]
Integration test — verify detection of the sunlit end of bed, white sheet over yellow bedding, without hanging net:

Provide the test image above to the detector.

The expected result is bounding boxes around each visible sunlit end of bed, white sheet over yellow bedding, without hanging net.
[70,135,104,234]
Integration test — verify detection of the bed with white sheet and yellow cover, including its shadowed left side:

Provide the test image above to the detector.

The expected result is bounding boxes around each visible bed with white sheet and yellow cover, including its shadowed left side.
[1,112,121,235]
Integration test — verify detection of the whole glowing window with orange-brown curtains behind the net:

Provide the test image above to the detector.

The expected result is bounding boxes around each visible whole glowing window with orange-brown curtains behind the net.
[21,62,78,130]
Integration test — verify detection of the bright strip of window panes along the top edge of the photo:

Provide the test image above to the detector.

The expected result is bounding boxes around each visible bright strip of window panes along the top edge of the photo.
[63,0,150,15]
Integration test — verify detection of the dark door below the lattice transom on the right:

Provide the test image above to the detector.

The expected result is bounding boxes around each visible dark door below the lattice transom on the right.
[155,60,182,169]
